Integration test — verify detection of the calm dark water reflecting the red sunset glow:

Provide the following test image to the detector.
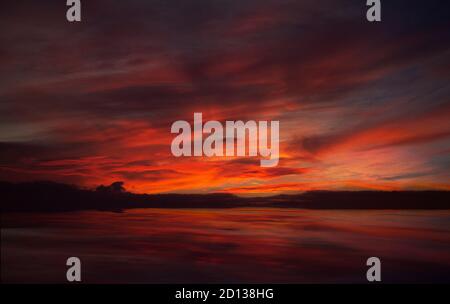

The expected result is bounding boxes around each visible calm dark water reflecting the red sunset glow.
[1,208,450,283]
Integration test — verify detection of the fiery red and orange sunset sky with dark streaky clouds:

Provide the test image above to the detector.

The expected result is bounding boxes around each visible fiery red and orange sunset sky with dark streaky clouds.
[0,0,450,195]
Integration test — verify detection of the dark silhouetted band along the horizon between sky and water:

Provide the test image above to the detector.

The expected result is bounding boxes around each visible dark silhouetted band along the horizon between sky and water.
[0,181,450,212]
